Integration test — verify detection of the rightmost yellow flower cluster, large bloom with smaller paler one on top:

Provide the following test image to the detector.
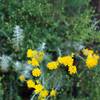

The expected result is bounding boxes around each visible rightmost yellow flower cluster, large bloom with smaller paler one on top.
[83,49,99,69]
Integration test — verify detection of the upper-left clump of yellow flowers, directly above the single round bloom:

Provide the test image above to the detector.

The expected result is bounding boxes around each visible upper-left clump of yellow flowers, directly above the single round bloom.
[27,49,44,66]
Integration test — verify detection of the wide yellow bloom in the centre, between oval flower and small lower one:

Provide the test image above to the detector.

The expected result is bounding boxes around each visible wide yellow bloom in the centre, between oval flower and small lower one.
[58,56,74,66]
